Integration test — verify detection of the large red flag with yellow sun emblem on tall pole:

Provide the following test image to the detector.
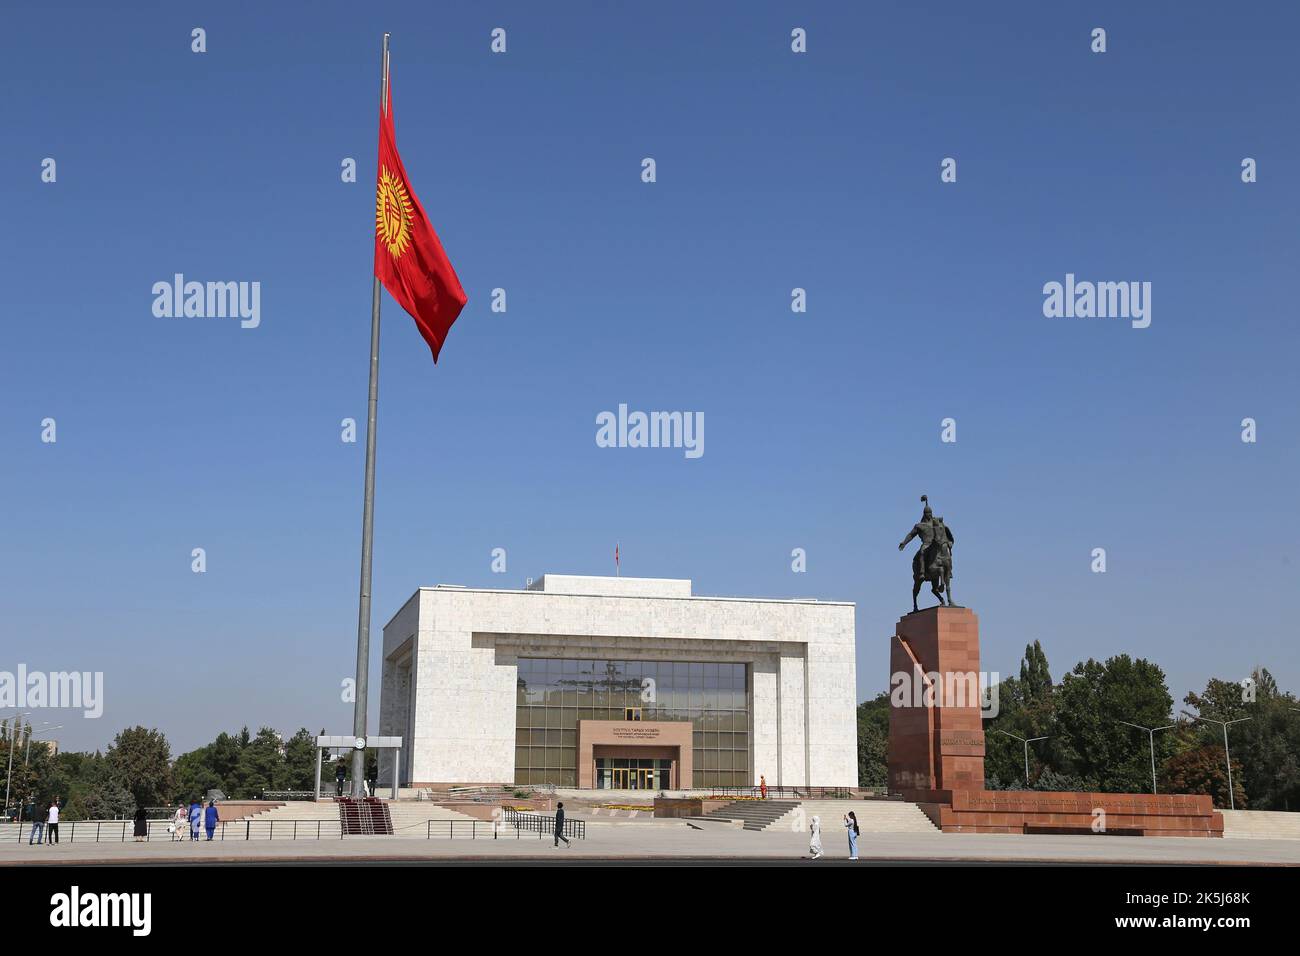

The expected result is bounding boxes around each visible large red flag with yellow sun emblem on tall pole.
[374,77,468,364]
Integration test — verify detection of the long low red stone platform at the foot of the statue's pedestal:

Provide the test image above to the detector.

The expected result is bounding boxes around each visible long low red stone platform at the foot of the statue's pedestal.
[904,790,1223,836]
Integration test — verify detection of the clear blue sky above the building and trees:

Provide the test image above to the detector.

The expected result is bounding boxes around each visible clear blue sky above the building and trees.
[0,3,1300,752]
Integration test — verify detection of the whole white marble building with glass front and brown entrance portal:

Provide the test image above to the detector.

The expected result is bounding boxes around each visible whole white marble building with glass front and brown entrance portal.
[378,575,857,790]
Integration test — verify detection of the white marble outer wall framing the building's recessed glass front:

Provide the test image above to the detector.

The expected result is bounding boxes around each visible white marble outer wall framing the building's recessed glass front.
[381,576,857,786]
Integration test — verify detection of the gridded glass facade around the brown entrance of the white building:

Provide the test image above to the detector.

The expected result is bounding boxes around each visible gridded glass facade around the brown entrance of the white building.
[515,657,753,790]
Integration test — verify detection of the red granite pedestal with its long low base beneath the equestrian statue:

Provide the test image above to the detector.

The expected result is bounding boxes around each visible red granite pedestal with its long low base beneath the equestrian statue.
[889,607,1223,836]
